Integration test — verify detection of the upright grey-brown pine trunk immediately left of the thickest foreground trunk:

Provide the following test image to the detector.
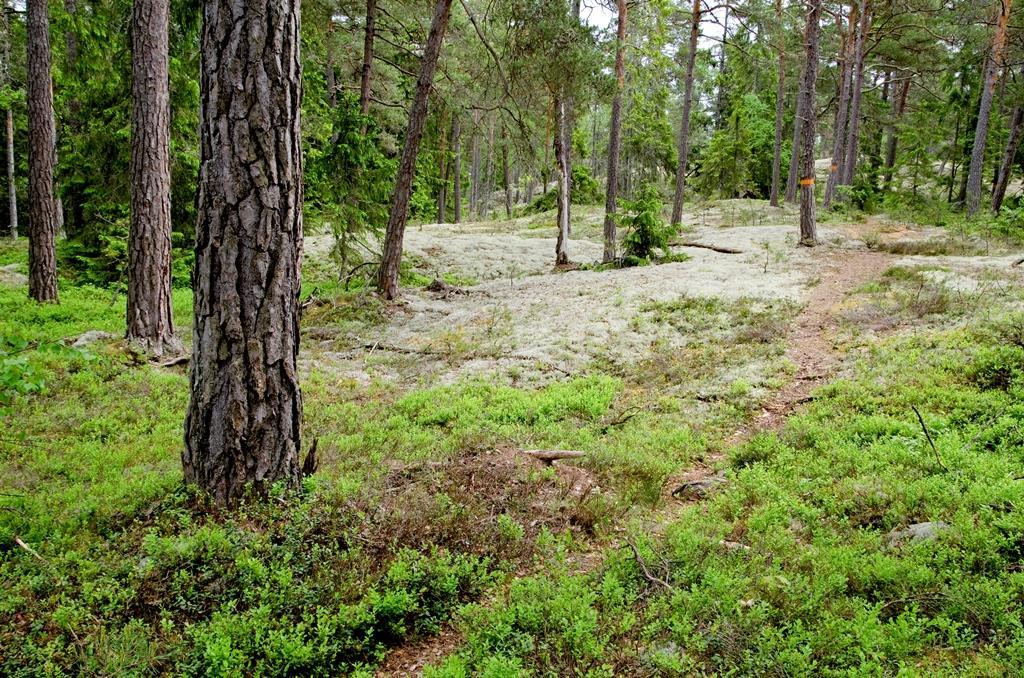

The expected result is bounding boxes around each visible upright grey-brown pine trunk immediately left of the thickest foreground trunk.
[126,0,182,355]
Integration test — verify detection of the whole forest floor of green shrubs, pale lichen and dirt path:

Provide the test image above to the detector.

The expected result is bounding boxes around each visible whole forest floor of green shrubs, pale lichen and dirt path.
[0,201,1024,677]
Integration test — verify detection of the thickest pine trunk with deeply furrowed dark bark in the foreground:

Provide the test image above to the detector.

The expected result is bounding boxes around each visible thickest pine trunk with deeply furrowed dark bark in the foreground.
[181,0,302,506]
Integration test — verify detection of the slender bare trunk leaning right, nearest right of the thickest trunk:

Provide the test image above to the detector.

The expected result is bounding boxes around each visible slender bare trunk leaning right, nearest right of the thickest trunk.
[377,0,452,299]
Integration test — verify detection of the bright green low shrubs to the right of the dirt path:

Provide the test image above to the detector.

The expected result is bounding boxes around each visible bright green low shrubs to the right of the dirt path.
[430,315,1024,678]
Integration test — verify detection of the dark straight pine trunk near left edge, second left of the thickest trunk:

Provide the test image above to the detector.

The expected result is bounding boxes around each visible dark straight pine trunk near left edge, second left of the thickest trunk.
[26,0,60,301]
